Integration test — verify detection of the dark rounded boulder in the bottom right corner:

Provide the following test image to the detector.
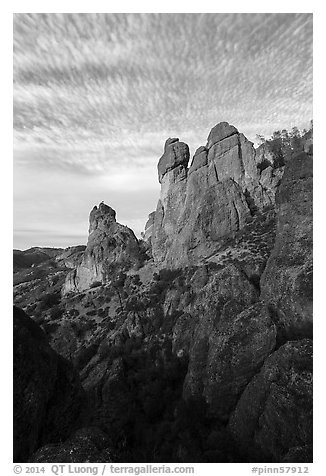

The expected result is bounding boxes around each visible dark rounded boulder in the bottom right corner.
[229,339,312,462]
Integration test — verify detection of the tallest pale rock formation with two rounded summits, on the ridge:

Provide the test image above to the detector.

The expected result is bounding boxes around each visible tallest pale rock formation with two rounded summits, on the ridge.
[151,122,283,268]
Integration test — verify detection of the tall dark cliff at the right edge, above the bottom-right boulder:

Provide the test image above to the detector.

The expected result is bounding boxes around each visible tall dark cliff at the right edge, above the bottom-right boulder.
[261,153,313,338]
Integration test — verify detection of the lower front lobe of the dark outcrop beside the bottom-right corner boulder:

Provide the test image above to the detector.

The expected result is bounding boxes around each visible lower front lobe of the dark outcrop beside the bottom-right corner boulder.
[185,304,276,421]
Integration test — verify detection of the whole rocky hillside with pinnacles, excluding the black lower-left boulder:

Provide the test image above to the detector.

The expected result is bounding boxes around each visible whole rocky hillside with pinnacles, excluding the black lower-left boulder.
[13,123,312,462]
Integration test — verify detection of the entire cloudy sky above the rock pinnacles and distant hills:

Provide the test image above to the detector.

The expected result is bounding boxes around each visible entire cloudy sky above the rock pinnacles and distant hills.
[13,13,312,249]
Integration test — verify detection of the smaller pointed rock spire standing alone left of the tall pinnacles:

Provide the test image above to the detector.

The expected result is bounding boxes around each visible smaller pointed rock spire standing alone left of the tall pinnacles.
[63,203,141,294]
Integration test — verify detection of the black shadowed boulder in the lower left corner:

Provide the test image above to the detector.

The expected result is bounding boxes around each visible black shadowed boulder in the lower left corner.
[14,308,85,462]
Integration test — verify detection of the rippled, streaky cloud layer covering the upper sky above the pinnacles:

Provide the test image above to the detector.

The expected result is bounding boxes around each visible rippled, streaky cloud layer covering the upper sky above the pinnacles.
[14,14,312,169]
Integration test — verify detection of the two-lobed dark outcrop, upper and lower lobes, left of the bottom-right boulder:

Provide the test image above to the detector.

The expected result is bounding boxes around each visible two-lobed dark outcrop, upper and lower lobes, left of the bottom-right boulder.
[182,266,276,420]
